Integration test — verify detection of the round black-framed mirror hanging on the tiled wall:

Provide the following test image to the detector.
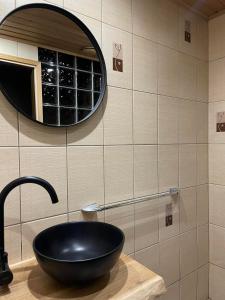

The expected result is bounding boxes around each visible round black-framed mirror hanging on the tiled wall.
[0,4,106,127]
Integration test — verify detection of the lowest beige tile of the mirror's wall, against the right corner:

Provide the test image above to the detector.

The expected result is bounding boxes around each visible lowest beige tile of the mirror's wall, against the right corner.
[197,264,209,300]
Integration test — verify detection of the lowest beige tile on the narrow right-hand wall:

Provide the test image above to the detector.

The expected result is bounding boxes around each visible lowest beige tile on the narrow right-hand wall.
[209,265,225,300]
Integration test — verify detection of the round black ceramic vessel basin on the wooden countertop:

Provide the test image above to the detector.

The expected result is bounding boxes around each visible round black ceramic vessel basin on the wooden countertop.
[33,222,124,284]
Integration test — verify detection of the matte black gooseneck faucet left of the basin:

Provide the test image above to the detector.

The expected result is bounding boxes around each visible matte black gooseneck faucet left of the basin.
[0,176,58,287]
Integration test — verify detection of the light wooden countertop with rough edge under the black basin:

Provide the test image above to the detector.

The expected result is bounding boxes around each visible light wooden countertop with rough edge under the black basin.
[0,255,165,300]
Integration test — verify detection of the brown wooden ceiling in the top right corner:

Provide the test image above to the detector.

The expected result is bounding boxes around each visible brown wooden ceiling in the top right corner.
[181,0,225,18]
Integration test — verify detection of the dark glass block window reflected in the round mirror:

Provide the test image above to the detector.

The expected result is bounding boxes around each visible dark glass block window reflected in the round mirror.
[38,48,102,126]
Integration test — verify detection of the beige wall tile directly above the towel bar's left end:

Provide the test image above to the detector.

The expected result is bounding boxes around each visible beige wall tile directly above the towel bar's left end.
[67,146,104,211]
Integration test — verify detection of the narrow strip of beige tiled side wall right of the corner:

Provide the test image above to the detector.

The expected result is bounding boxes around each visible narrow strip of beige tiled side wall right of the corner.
[209,11,225,300]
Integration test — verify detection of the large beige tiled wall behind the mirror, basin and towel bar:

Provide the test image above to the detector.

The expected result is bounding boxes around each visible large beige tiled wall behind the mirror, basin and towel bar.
[0,0,208,300]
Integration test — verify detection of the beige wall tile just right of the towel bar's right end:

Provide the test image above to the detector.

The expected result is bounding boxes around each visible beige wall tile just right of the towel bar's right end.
[180,187,197,232]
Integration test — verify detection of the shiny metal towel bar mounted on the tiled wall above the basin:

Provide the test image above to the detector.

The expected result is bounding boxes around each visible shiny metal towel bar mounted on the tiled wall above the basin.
[81,188,179,213]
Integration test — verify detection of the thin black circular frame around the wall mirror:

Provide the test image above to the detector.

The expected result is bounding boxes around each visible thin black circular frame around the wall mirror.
[0,3,107,128]
